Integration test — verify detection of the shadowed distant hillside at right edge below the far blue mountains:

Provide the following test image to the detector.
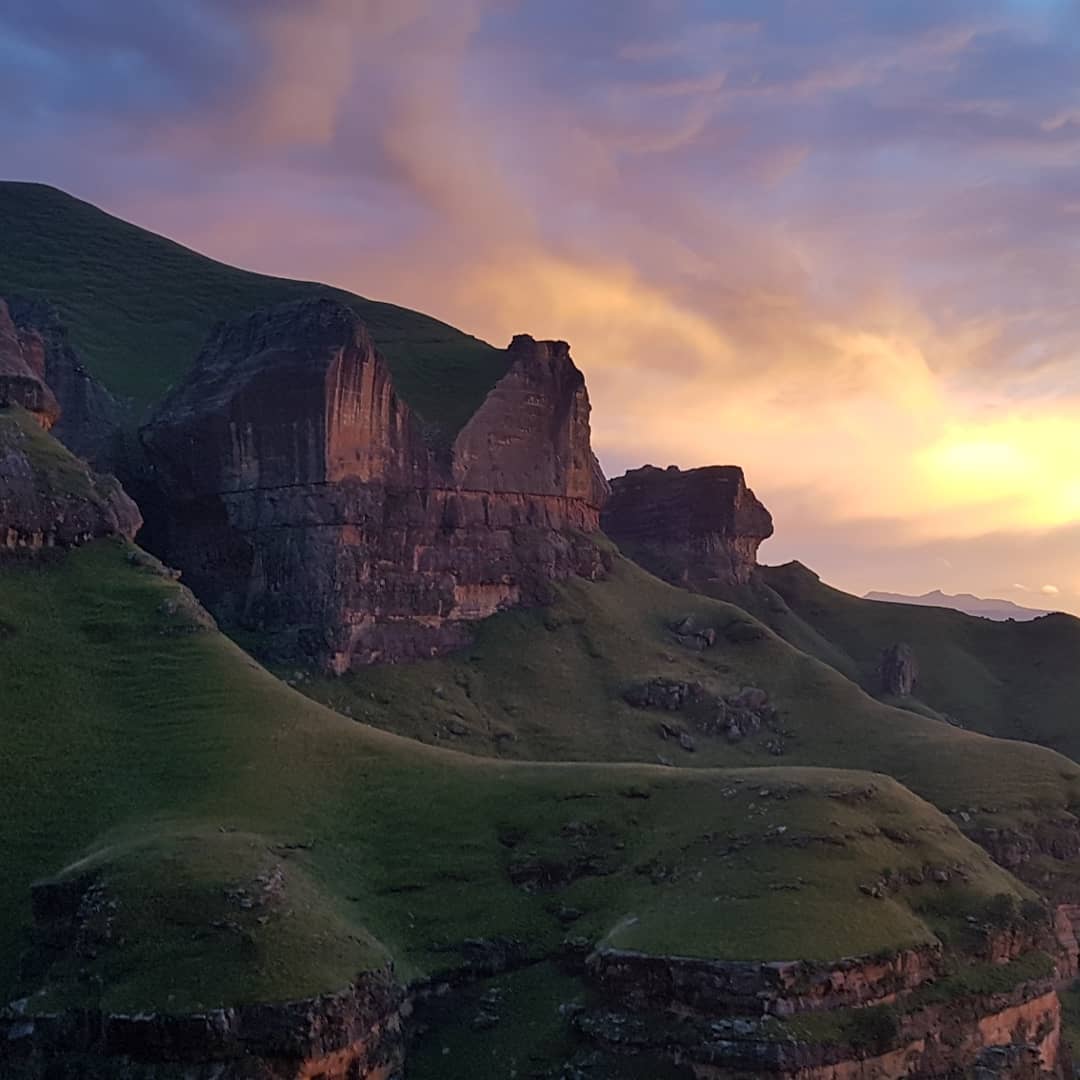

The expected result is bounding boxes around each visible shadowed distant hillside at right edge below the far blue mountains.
[761,563,1080,760]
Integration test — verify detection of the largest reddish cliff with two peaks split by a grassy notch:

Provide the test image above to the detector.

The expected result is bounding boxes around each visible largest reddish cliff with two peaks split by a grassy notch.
[143,299,607,672]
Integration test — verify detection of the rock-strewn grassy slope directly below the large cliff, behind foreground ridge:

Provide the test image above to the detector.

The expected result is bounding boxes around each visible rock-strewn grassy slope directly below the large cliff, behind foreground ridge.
[300,548,1080,820]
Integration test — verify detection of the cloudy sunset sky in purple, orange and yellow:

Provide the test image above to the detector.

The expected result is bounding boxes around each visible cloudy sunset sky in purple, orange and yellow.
[0,0,1080,613]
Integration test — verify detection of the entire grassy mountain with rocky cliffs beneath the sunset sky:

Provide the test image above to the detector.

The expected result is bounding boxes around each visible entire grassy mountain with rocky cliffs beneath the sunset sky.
[0,185,1080,1080]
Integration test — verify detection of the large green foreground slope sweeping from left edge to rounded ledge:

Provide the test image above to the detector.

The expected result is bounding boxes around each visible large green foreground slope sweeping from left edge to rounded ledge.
[0,542,1036,1009]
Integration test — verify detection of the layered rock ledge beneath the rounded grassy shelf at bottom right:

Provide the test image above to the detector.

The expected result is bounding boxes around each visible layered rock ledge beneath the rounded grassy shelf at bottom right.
[575,947,1067,1080]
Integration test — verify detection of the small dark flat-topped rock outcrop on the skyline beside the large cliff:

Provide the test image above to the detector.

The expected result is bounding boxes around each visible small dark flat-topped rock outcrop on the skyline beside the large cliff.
[602,465,772,590]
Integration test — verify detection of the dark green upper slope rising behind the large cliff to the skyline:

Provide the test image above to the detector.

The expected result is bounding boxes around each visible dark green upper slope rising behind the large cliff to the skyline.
[0,181,507,432]
